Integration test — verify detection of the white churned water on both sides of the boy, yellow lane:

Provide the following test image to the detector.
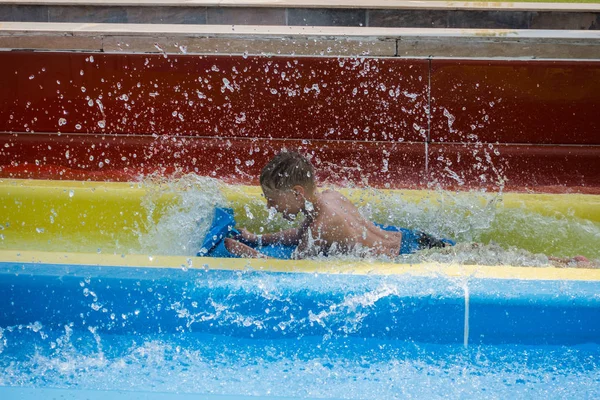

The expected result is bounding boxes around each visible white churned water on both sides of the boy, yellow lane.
[136,175,600,267]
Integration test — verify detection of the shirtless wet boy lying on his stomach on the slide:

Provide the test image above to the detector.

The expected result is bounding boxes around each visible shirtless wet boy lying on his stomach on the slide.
[225,152,447,259]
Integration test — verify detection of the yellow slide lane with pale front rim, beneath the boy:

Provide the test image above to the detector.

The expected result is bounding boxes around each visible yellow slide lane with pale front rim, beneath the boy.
[0,179,600,280]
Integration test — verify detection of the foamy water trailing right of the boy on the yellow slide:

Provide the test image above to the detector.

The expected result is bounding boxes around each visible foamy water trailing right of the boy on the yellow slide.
[352,191,600,265]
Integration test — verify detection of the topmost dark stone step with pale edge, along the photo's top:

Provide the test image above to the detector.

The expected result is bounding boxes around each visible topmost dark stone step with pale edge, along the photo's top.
[0,0,600,30]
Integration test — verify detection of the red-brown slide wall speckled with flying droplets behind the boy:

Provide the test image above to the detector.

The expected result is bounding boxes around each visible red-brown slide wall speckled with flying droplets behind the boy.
[0,52,600,192]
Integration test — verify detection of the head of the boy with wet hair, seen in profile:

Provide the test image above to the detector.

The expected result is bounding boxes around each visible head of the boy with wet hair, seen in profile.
[260,152,316,219]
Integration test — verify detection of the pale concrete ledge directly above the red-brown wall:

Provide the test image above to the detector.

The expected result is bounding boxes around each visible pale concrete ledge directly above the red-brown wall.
[0,22,600,60]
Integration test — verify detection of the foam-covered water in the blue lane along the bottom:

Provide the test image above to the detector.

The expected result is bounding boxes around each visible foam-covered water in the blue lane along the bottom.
[0,331,600,400]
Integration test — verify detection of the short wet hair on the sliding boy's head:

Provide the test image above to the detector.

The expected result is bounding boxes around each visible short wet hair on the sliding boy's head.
[260,151,315,191]
